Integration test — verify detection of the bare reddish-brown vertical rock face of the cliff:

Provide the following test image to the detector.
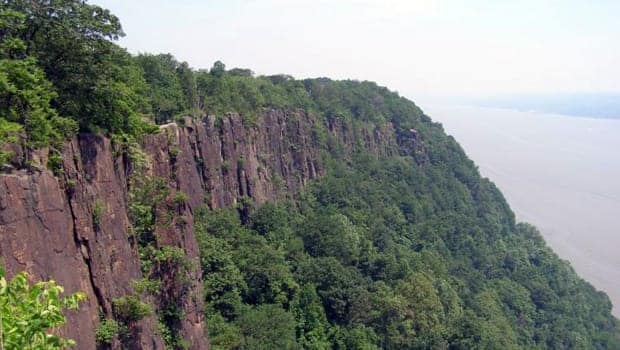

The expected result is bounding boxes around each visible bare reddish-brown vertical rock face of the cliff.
[0,110,398,349]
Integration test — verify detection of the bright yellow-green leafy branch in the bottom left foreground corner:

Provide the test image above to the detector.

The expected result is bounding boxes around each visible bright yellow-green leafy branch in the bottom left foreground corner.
[0,268,86,350]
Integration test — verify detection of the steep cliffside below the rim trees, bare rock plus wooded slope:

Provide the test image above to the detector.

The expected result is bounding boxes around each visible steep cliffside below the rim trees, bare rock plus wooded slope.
[0,93,618,349]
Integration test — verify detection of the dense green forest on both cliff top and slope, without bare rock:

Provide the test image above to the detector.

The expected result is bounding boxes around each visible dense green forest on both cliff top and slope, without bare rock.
[0,0,620,349]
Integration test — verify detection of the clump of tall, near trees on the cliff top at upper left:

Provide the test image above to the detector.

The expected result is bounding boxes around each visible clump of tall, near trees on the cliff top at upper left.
[0,0,153,158]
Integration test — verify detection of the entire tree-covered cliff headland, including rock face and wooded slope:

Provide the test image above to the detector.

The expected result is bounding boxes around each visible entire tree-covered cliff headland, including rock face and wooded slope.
[0,0,620,349]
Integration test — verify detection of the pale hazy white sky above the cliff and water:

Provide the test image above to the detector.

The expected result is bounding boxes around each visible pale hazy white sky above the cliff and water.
[92,0,620,97]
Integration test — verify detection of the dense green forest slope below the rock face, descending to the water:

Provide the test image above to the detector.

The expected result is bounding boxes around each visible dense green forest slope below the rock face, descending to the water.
[194,113,620,349]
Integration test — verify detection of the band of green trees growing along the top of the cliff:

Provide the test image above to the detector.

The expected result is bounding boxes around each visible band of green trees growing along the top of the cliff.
[0,0,432,158]
